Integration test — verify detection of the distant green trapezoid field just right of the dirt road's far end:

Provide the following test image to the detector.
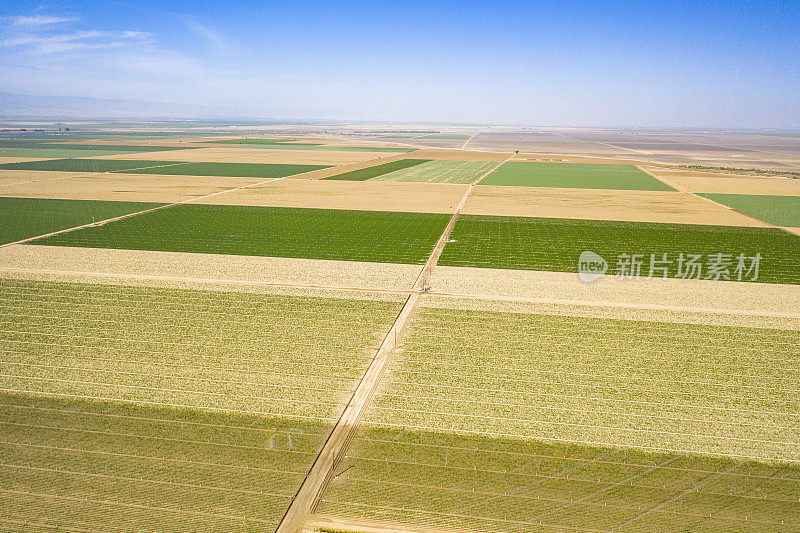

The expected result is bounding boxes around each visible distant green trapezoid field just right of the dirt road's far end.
[480,162,674,191]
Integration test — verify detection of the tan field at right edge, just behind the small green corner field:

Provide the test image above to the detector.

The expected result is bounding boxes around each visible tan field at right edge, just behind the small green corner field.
[647,168,800,196]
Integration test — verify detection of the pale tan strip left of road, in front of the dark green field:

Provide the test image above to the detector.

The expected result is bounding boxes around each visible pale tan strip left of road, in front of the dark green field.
[0,244,420,291]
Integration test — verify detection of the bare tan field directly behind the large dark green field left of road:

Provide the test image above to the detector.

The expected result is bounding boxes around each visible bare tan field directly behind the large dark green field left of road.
[198,179,468,213]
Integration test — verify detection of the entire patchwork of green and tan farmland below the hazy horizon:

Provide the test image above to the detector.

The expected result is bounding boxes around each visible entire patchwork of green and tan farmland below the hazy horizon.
[0,125,800,533]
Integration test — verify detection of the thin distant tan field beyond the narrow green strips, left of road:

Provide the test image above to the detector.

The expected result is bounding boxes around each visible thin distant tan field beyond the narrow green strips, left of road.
[90,145,394,165]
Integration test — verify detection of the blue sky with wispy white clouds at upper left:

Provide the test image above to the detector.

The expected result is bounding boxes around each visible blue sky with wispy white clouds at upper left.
[0,0,800,129]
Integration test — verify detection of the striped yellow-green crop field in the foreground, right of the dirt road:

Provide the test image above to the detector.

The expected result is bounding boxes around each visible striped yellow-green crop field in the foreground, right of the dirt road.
[319,307,800,532]
